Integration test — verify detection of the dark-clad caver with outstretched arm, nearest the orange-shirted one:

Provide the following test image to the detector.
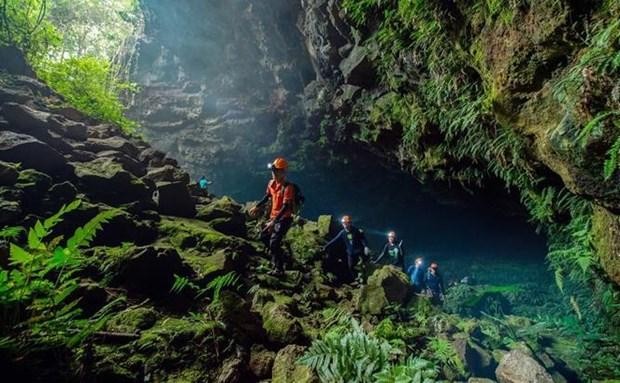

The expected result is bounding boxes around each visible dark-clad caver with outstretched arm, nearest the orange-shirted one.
[323,215,370,282]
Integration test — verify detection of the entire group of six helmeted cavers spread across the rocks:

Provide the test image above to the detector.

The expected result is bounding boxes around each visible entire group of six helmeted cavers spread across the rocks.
[198,157,444,304]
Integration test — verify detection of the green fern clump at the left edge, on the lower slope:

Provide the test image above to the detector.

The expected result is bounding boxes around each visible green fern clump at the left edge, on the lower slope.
[0,201,118,352]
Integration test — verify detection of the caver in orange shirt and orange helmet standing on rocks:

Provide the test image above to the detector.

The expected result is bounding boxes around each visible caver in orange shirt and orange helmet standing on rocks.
[249,157,295,275]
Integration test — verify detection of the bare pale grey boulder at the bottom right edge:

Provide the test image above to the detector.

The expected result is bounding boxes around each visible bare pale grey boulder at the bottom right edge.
[495,350,553,383]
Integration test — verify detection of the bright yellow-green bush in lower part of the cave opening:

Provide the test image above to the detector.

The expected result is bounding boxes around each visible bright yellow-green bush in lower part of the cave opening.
[38,56,137,133]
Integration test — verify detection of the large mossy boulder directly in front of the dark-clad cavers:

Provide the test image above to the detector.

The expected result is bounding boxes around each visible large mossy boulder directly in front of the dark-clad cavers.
[358,265,409,315]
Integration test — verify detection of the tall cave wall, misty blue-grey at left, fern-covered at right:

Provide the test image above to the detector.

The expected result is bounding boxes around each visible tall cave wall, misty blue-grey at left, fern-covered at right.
[132,0,620,283]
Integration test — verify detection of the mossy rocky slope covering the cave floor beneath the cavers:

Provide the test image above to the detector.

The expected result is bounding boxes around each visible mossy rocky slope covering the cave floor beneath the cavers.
[0,51,600,383]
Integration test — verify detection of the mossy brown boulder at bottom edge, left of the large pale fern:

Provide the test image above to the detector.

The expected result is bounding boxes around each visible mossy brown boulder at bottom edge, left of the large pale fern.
[271,344,319,383]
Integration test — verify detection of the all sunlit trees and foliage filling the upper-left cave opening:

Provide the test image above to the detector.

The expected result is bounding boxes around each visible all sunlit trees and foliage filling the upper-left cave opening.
[0,0,141,133]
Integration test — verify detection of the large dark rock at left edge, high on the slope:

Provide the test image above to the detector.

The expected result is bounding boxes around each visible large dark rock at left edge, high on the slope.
[0,131,67,174]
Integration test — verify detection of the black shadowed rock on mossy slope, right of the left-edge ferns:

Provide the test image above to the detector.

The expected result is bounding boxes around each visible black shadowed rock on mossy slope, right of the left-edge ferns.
[112,247,191,299]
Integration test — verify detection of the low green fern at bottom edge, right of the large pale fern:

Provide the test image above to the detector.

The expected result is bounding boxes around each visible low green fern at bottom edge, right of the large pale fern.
[375,357,439,383]
